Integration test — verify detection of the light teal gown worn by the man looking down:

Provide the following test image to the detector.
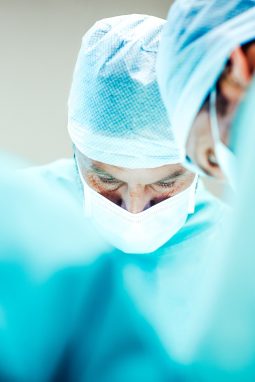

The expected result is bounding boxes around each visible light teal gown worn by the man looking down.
[23,160,226,366]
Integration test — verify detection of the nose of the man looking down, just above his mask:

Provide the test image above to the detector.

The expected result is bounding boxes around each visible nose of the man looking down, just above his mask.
[121,187,154,214]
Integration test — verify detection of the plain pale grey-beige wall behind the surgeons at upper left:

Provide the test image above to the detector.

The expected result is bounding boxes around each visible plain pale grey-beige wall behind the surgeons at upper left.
[0,0,171,164]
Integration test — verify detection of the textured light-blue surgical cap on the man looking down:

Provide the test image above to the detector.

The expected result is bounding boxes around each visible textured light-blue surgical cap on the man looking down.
[68,15,180,168]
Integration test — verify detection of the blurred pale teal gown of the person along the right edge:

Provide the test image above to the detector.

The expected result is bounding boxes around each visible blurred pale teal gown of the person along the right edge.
[178,81,255,382]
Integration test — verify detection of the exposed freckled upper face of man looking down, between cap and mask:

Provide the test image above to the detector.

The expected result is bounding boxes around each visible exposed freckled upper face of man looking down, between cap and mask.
[75,149,194,214]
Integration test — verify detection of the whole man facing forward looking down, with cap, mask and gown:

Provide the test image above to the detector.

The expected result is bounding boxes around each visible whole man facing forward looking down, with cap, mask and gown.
[24,15,225,360]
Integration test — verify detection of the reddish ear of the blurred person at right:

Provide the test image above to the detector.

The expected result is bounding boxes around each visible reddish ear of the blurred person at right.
[229,46,252,88]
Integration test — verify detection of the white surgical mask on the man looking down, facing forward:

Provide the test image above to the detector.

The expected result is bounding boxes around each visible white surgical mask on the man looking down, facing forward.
[80,167,197,254]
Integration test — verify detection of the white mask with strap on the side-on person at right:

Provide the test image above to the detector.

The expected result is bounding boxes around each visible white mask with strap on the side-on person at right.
[210,88,237,190]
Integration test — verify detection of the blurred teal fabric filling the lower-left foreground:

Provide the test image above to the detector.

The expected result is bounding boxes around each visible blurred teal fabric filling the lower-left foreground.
[0,162,179,382]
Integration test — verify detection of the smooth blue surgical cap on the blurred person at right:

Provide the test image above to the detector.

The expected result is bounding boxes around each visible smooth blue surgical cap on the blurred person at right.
[157,0,255,158]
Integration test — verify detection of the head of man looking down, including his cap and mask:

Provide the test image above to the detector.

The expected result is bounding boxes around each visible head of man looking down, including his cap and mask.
[68,15,197,253]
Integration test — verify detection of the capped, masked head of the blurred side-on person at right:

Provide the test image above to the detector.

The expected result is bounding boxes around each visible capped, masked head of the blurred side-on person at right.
[158,0,255,189]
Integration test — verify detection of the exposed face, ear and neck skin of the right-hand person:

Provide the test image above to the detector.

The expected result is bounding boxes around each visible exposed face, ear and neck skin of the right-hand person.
[186,42,255,180]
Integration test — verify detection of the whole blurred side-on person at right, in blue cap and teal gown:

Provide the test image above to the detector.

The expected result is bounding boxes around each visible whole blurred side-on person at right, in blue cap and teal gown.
[158,0,255,381]
